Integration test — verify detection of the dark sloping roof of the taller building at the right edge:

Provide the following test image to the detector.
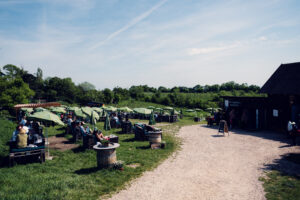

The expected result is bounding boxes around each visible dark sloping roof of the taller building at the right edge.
[260,62,300,95]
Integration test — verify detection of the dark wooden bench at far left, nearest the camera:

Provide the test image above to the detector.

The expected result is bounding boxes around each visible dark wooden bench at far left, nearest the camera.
[9,146,45,167]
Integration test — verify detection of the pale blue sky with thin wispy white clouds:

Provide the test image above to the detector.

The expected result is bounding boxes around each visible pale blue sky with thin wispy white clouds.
[0,0,300,89]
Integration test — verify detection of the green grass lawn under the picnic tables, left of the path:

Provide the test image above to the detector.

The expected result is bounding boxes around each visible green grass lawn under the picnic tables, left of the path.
[0,118,202,200]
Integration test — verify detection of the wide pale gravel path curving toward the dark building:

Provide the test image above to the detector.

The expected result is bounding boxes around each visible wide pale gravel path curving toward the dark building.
[107,125,300,200]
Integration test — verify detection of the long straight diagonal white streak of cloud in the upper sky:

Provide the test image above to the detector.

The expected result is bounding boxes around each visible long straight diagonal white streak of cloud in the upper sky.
[90,0,167,50]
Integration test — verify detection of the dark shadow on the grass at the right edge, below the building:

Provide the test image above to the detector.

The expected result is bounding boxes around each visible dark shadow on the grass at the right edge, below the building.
[263,153,300,180]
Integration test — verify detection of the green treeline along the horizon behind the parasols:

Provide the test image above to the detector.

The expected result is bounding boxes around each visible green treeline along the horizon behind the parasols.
[0,65,260,109]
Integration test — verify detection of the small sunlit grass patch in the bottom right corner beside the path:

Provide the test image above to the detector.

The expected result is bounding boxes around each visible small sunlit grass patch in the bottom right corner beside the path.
[260,170,300,200]
